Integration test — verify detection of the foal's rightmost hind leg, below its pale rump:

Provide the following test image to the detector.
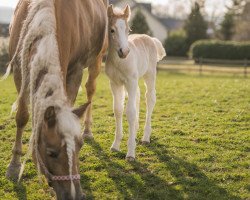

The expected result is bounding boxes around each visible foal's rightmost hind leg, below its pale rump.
[142,72,156,144]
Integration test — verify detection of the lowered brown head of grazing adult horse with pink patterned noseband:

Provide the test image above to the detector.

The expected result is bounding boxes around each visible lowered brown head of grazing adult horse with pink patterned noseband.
[33,103,89,200]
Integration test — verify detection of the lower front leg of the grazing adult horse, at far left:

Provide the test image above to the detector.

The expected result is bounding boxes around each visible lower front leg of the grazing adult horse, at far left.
[6,97,29,180]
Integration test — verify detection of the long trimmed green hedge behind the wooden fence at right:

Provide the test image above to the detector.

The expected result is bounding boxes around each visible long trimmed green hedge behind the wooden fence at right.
[190,40,250,60]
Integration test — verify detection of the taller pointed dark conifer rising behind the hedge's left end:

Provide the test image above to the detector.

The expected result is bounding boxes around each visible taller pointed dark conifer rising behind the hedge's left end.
[184,3,208,46]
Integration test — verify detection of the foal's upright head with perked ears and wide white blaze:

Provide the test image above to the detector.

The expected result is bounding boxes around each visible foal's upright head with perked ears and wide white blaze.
[108,5,130,58]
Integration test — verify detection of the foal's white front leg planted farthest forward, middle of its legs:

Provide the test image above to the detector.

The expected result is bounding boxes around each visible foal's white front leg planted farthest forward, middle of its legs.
[126,81,138,161]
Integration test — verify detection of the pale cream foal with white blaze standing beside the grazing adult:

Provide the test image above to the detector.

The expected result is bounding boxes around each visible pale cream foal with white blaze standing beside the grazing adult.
[105,5,166,161]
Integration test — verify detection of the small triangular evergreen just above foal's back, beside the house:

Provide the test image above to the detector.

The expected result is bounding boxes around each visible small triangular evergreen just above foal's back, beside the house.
[131,10,151,35]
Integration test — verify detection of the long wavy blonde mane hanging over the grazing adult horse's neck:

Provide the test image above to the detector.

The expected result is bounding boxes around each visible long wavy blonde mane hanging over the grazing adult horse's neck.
[17,0,80,197]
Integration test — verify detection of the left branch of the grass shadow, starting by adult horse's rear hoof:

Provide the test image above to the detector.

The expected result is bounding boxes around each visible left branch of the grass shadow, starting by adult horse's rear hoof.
[83,141,182,199]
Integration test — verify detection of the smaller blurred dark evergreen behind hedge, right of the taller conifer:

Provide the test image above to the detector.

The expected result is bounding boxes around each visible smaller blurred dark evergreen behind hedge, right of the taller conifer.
[220,11,235,40]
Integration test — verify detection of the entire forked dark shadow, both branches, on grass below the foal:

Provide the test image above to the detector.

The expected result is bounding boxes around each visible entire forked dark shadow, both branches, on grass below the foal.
[83,141,240,200]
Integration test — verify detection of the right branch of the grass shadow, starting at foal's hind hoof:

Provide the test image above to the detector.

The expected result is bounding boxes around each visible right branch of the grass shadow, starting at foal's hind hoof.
[147,143,240,200]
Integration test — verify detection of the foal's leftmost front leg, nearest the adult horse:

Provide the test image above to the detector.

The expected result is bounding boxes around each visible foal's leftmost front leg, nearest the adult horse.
[110,82,125,151]
